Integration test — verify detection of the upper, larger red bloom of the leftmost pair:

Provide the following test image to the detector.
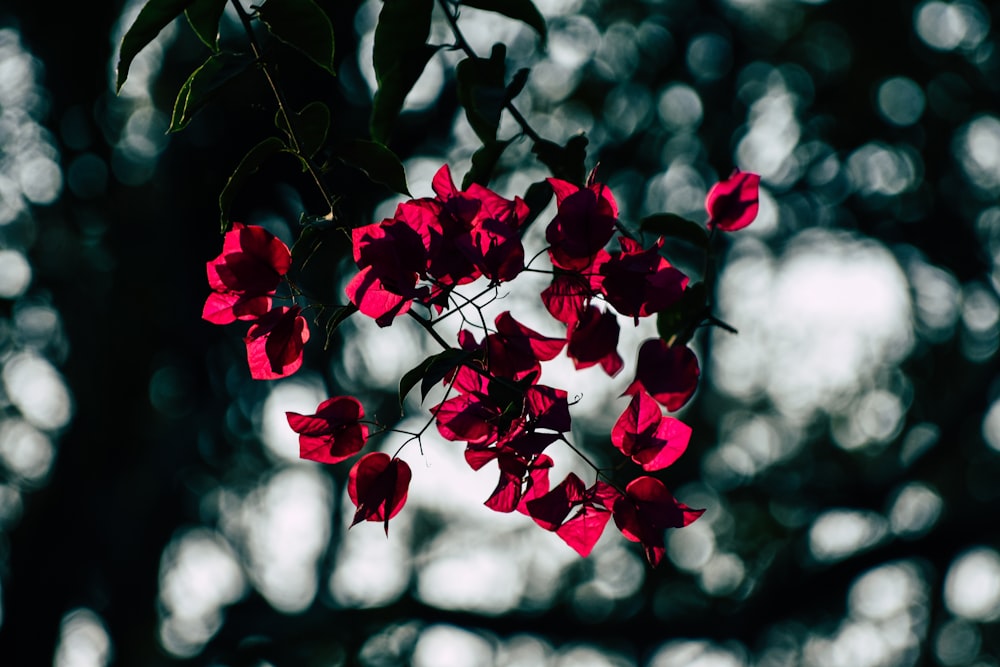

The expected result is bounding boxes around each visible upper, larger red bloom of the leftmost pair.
[202,222,292,324]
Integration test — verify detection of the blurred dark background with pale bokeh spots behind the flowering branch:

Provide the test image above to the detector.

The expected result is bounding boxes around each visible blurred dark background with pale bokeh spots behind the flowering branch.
[0,0,1000,667]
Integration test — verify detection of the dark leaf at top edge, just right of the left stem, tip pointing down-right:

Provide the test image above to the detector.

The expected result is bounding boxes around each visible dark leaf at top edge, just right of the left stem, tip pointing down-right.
[257,0,336,74]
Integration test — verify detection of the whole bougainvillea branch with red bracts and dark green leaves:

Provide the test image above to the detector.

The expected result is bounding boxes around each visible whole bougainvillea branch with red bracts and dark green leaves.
[118,0,759,565]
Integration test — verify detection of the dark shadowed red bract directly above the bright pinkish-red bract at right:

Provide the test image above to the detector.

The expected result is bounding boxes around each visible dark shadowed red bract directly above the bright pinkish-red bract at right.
[622,338,701,412]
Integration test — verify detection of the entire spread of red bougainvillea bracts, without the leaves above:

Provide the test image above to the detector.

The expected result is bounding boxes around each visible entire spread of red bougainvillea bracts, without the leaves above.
[204,166,759,565]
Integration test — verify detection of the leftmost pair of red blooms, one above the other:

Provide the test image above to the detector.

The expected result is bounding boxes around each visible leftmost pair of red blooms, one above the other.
[202,222,309,380]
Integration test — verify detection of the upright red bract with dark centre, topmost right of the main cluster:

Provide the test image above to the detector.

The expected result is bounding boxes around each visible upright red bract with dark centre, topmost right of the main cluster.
[545,178,618,271]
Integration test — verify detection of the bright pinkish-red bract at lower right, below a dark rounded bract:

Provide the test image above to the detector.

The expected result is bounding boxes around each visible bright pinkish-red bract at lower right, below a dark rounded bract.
[611,391,691,471]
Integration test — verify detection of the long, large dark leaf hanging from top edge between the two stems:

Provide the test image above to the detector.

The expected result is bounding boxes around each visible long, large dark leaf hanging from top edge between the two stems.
[369,0,440,144]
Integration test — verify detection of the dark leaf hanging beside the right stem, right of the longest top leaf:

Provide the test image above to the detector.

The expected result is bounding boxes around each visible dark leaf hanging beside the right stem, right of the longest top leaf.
[455,44,507,143]
